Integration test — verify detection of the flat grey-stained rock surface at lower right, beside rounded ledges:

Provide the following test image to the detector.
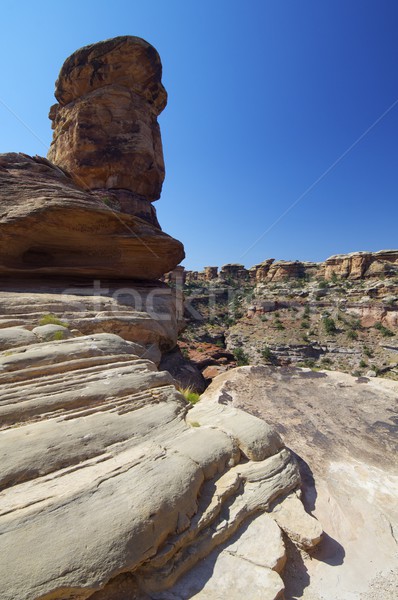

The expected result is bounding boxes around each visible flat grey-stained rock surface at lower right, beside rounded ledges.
[197,367,398,600]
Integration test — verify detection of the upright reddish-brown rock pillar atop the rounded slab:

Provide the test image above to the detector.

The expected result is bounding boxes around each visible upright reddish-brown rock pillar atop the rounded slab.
[48,36,167,201]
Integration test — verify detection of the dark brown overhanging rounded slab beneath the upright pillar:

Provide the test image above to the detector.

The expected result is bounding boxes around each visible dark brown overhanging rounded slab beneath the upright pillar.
[0,153,184,279]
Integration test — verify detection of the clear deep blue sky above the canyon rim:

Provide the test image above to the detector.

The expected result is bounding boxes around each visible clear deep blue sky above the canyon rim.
[0,0,398,269]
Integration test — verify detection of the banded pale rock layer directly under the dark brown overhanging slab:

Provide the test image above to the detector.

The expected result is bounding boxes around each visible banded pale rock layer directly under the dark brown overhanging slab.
[0,278,183,364]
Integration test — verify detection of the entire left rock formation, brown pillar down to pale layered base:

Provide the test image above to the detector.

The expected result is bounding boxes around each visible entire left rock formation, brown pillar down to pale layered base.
[0,36,322,600]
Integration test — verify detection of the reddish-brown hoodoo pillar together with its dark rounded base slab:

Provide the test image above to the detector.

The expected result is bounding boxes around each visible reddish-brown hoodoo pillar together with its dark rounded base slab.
[0,36,184,280]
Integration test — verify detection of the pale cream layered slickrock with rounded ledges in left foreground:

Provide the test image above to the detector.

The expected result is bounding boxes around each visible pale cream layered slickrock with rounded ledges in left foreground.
[0,333,321,600]
